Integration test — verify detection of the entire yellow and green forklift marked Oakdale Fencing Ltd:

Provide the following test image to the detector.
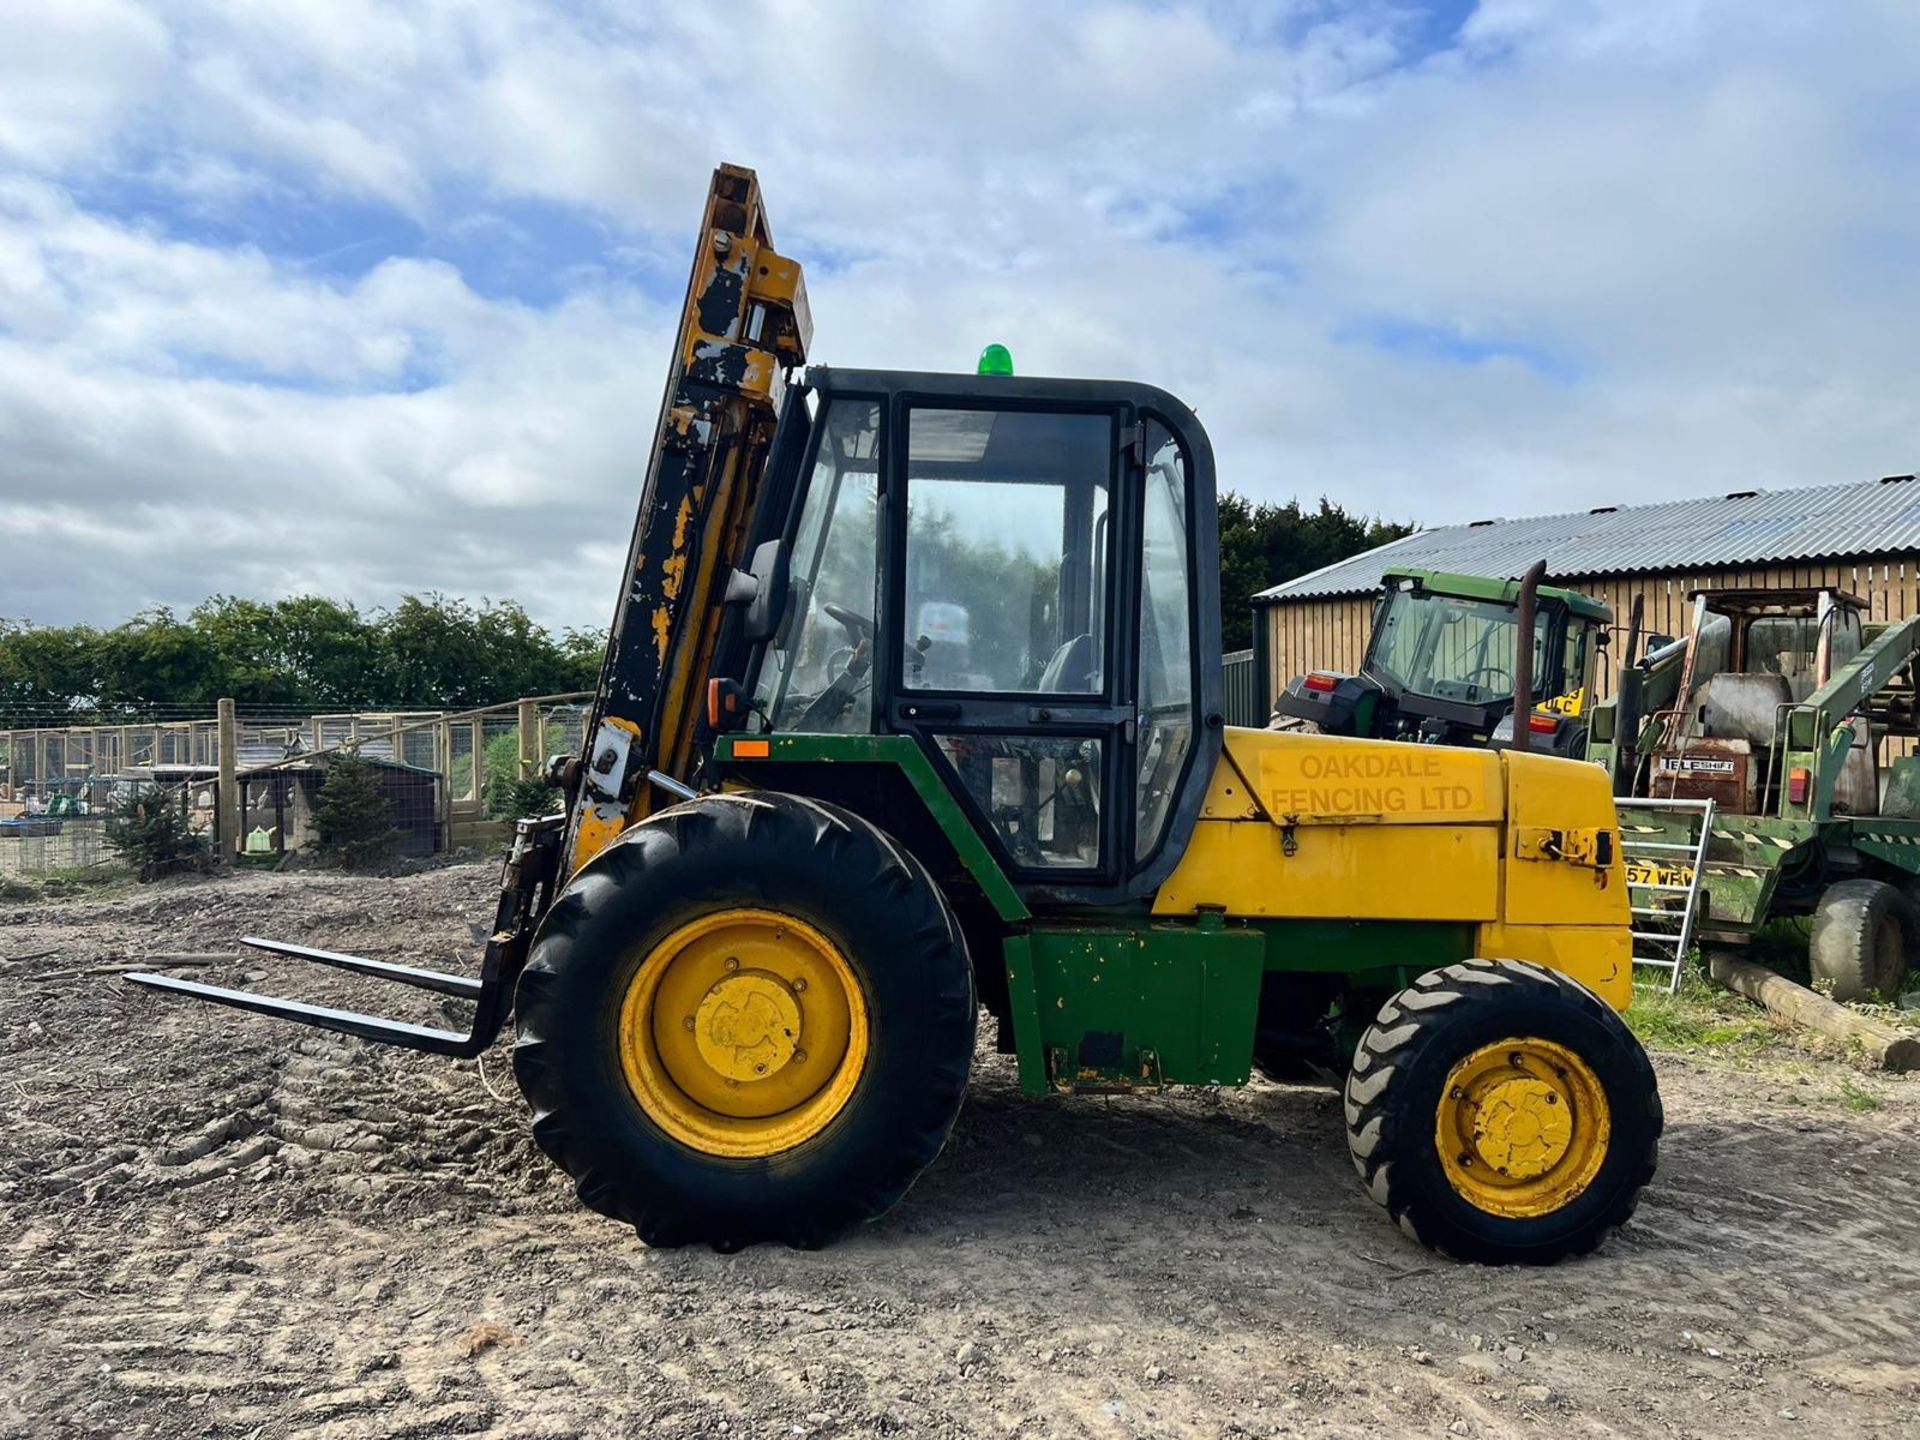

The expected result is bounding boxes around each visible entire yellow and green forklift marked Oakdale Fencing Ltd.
[132,167,1661,1261]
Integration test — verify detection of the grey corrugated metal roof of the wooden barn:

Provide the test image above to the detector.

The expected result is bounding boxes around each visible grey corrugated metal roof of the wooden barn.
[1254,474,1920,601]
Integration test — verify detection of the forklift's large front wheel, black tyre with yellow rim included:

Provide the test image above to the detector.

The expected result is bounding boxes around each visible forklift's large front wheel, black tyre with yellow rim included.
[513,795,975,1250]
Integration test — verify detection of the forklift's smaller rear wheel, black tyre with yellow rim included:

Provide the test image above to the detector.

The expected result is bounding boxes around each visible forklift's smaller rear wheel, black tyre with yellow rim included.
[1346,960,1663,1265]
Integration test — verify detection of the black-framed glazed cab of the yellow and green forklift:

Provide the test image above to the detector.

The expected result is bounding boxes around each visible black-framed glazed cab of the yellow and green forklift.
[733,367,1221,900]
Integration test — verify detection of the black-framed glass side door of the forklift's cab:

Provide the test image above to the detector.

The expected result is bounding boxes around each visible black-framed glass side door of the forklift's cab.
[885,396,1139,891]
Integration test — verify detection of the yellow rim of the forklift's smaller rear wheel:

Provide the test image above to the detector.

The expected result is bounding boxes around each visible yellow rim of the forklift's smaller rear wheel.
[1434,1037,1613,1219]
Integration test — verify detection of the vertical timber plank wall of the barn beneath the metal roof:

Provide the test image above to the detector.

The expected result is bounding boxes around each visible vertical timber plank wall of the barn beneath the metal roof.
[1265,553,1920,718]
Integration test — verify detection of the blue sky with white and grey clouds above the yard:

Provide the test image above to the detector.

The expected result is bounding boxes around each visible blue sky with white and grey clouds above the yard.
[0,0,1920,626]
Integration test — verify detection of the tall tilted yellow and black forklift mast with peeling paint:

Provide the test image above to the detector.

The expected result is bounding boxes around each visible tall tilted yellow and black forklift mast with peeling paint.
[555,165,812,879]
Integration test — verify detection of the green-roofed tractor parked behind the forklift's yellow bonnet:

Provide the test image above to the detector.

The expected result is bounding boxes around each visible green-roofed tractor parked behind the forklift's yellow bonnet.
[1271,568,1613,758]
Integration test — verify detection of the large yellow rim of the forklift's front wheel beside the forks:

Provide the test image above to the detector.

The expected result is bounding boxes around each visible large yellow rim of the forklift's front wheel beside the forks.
[620,908,868,1158]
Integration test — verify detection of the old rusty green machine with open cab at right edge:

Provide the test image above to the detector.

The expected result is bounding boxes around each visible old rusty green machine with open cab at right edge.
[1590,588,1920,1000]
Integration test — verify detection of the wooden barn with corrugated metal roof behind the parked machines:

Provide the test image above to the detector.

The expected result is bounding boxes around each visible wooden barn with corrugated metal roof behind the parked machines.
[1254,474,1920,721]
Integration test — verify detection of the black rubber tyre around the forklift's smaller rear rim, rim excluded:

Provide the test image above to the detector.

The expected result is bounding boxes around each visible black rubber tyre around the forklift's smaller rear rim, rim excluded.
[1346,960,1665,1265]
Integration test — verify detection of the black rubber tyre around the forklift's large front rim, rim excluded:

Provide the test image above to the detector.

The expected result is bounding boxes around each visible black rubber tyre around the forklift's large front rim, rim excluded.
[513,795,975,1250]
